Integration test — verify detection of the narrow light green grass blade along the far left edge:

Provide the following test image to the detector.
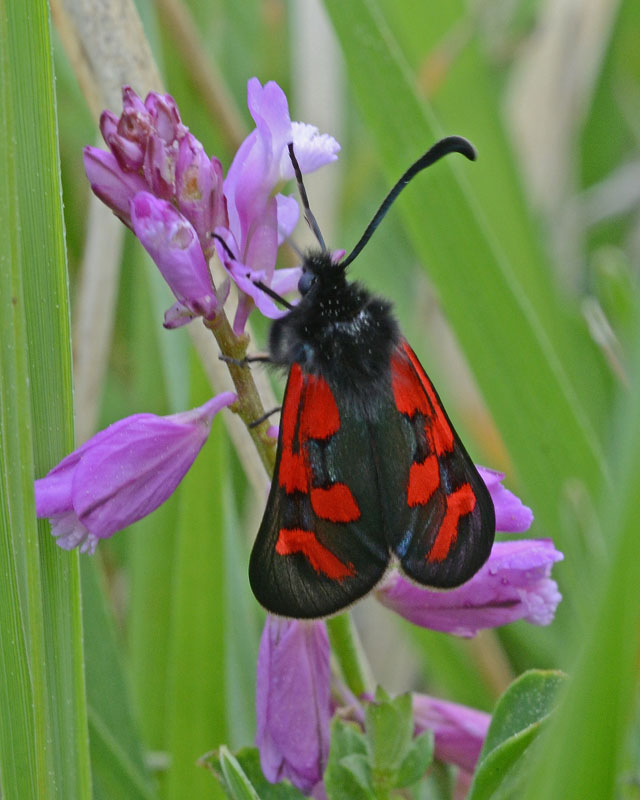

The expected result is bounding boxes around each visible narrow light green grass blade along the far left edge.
[0,20,40,798]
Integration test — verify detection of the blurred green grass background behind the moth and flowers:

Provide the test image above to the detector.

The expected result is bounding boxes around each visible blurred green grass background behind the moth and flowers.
[0,0,640,800]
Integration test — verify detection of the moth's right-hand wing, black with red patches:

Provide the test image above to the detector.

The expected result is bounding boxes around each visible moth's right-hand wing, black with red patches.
[375,340,495,588]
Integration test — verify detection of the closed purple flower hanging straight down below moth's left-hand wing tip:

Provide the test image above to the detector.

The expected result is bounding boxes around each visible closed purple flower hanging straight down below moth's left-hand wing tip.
[256,615,331,793]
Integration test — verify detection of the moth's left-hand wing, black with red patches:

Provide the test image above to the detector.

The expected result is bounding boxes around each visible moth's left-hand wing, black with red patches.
[249,364,390,618]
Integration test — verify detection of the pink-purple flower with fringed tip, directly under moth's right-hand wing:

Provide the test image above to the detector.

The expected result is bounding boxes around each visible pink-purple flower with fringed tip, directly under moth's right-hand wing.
[376,539,563,637]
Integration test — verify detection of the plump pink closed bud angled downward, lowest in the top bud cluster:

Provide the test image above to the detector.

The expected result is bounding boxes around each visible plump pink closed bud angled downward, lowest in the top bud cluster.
[131,192,218,319]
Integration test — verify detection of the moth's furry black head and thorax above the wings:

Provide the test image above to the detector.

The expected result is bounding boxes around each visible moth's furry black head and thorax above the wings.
[269,250,400,402]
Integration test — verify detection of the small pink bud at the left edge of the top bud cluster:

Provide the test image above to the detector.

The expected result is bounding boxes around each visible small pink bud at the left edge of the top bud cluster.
[83,147,147,227]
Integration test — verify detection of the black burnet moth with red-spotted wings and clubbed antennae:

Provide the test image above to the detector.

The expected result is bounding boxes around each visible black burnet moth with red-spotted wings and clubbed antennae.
[249,136,495,618]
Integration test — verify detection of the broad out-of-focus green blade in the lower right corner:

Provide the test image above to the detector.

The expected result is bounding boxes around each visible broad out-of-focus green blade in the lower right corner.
[526,336,640,800]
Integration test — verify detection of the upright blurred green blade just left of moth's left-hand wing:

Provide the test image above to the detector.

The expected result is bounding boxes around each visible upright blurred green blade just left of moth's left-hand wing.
[165,371,230,800]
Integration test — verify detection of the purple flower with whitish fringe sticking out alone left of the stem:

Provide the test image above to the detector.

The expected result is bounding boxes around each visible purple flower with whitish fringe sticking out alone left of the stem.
[35,392,236,553]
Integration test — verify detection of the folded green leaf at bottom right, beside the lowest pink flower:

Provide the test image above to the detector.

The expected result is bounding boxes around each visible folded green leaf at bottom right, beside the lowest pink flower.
[469,670,565,800]
